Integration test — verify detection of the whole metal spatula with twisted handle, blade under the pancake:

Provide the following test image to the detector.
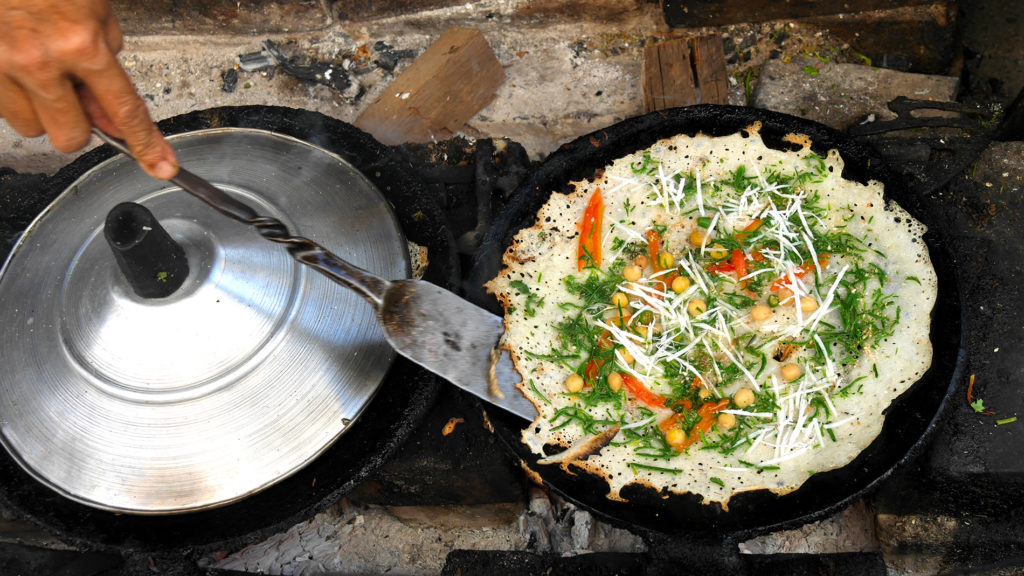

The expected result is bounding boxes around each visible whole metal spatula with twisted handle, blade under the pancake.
[92,128,538,420]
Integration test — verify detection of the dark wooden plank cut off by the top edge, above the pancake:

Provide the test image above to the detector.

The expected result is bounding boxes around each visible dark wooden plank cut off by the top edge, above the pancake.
[662,0,933,28]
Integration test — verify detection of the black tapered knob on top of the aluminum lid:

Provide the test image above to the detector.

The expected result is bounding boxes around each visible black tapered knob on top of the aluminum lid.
[103,202,188,298]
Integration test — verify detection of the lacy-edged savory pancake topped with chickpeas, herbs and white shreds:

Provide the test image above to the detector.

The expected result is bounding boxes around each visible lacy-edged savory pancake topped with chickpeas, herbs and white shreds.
[487,126,937,504]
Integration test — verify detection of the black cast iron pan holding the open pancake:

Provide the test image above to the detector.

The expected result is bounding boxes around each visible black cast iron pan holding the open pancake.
[468,105,962,536]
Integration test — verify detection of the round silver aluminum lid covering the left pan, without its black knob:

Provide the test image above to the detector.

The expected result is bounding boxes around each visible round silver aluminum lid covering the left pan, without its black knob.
[0,128,410,515]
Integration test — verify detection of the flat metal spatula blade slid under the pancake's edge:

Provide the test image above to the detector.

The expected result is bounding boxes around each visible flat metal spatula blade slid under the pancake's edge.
[379,280,538,420]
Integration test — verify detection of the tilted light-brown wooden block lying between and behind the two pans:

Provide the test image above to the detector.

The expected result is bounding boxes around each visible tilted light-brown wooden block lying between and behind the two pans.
[354,28,505,145]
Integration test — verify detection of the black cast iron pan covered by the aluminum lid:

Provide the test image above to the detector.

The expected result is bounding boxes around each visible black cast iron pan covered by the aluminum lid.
[0,107,459,552]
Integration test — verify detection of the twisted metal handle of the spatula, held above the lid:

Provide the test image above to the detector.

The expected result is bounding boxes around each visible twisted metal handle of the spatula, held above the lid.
[92,128,390,310]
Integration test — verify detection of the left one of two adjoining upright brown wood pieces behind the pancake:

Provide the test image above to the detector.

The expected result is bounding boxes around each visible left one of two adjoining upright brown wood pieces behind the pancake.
[643,38,697,112]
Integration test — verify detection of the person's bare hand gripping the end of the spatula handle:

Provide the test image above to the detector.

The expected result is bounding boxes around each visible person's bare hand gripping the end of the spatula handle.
[0,0,178,179]
